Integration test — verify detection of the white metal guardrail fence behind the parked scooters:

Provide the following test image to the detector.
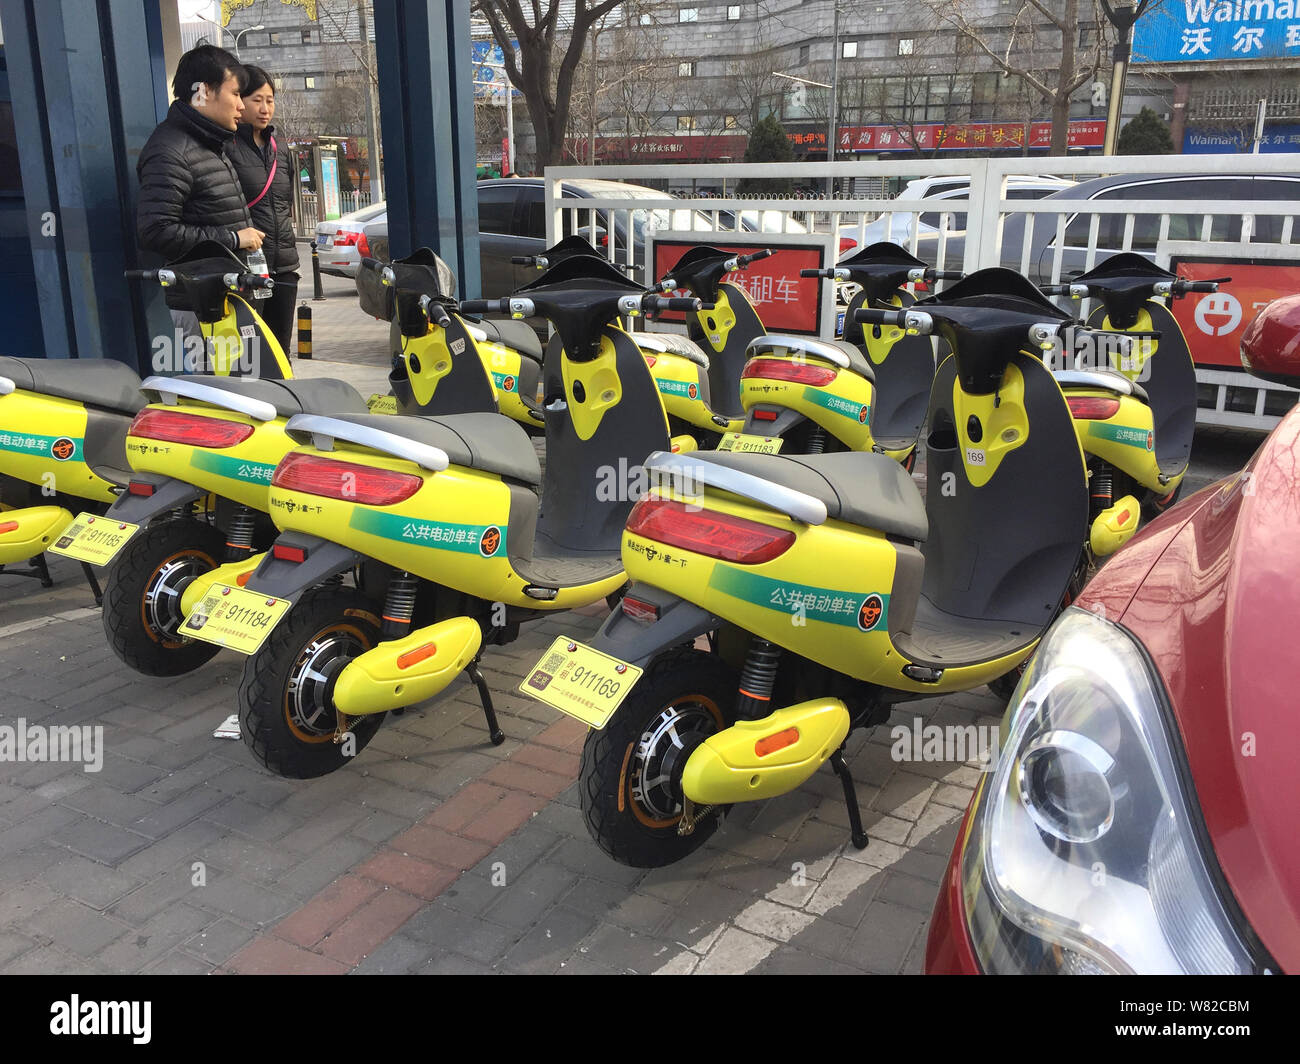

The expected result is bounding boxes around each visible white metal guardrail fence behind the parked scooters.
[545,153,1300,429]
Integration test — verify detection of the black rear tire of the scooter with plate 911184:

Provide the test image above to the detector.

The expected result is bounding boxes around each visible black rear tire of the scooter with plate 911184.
[239,588,386,779]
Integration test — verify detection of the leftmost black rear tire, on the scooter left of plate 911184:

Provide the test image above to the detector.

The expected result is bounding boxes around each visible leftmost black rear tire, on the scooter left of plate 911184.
[103,518,226,676]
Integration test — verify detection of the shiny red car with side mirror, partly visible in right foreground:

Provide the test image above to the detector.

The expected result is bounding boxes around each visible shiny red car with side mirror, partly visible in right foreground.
[926,295,1300,973]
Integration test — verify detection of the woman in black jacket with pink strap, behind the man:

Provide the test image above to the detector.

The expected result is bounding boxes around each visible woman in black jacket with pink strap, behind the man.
[228,66,298,354]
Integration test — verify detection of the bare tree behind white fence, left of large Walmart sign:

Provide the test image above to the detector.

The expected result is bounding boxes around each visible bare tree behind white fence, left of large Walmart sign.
[928,0,1113,155]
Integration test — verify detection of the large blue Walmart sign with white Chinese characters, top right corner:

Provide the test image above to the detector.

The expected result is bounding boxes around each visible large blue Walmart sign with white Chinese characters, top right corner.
[1132,0,1300,62]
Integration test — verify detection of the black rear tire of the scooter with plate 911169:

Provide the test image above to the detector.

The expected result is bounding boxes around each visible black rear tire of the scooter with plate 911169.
[579,648,737,868]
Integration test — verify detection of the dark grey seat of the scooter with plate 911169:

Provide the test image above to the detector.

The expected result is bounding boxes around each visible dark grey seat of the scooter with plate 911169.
[692,451,930,542]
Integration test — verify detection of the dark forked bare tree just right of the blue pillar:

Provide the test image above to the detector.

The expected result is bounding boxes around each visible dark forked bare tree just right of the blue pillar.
[476,0,623,169]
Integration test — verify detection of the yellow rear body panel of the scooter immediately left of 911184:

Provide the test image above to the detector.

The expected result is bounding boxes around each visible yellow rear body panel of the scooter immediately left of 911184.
[126,399,294,512]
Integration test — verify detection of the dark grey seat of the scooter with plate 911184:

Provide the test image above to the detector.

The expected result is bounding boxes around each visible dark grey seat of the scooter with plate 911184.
[322,412,542,488]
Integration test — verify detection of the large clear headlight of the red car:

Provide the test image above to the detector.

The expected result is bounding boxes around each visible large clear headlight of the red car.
[962,609,1253,974]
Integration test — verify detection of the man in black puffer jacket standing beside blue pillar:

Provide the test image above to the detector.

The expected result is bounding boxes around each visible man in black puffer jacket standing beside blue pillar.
[135,44,264,260]
